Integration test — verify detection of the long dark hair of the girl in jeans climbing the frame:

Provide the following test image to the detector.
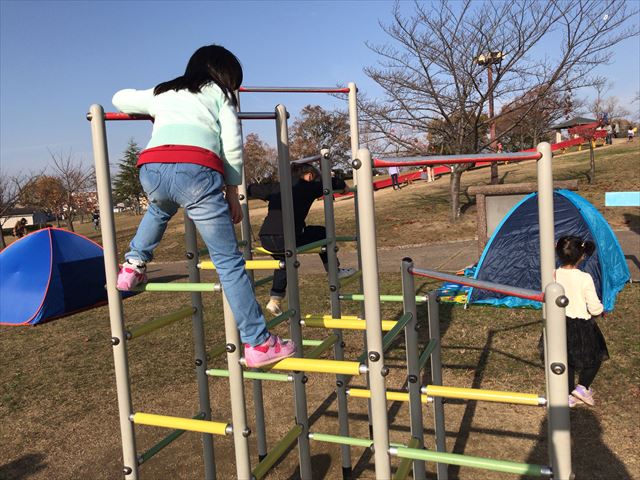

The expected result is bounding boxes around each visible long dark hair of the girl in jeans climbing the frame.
[153,45,242,106]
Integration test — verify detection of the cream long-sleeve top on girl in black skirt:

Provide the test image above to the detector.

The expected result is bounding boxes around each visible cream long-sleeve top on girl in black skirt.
[555,268,604,320]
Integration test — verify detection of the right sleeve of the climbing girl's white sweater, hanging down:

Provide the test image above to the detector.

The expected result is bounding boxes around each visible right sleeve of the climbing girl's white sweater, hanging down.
[218,97,242,185]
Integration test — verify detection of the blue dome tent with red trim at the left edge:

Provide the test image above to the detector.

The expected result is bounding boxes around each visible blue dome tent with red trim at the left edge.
[0,228,107,325]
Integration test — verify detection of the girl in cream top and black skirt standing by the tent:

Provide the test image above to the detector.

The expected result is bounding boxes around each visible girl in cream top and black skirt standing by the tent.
[555,236,609,407]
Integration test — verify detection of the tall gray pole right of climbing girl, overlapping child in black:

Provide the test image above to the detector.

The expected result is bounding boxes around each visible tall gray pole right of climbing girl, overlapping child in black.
[276,105,312,480]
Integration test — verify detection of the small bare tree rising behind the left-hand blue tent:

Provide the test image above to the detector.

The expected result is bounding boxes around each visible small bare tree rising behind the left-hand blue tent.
[49,150,95,232]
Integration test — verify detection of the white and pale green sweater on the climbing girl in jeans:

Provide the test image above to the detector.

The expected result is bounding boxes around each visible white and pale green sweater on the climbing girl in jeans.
[112,83,242,185]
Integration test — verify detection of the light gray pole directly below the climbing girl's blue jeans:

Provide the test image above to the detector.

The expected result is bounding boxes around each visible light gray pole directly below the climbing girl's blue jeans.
[222,291,251,478]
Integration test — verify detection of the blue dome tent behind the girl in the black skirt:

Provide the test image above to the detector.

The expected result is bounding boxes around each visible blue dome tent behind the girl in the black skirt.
[467,190,631,312]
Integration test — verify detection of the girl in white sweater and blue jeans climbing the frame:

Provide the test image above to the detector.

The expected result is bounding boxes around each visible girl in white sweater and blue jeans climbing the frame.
[113,45,296,367]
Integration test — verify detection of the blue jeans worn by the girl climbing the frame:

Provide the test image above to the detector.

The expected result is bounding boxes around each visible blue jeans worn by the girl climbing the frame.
[125,163,269,345]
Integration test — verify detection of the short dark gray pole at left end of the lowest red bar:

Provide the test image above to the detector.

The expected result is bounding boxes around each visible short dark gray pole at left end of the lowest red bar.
[401,258,426,480]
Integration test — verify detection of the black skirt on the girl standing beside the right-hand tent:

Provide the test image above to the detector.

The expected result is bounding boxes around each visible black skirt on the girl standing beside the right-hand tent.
[538,317,609,370]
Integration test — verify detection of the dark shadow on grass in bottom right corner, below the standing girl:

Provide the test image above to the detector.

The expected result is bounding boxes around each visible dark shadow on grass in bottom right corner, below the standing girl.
[520,406,632,480]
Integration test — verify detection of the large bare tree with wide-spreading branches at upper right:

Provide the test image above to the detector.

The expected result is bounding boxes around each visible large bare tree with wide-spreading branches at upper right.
[360,0,636,220]
